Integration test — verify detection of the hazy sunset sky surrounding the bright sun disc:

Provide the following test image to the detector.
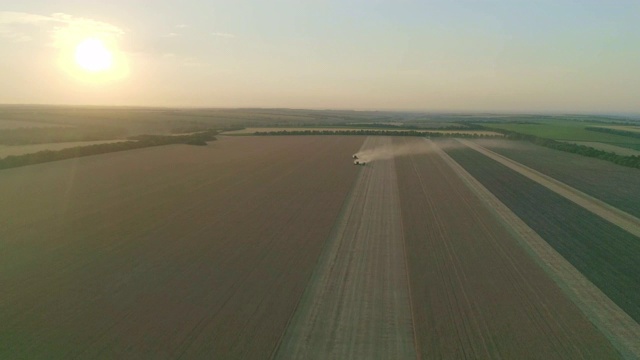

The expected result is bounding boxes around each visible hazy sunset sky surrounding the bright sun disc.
[0,0,640,113]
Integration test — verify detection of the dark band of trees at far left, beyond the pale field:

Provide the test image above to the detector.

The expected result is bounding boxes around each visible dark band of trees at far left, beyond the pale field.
[0,126,126,145]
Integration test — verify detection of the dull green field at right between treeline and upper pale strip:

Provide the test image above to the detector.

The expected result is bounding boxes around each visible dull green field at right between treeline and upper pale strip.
[474,139,640,218]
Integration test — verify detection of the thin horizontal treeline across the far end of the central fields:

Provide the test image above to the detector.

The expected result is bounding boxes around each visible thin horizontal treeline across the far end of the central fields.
[254,129,502,139]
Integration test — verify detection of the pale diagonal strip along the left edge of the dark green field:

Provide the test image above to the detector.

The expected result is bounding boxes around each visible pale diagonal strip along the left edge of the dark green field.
[427,140,640,359]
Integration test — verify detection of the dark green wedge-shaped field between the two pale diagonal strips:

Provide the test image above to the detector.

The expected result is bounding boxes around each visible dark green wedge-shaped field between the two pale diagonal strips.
[447,142,640,322]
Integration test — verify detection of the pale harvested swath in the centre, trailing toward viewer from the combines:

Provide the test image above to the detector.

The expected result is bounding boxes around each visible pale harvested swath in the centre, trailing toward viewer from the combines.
[275,137,416,359]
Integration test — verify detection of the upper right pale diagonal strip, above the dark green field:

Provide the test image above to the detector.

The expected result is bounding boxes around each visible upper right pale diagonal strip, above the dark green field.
[456,139,640,237]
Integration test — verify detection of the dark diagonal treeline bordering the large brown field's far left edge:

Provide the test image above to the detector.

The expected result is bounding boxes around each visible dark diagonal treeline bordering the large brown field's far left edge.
[0,130,217,169]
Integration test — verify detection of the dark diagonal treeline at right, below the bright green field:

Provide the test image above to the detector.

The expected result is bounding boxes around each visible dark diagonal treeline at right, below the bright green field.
[492,129,640,169]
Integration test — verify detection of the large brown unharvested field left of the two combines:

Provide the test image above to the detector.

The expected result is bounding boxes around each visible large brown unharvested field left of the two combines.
[0,137,363,359]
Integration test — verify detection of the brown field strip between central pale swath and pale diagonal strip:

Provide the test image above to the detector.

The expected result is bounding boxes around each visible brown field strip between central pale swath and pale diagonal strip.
[396,139,618,359]
